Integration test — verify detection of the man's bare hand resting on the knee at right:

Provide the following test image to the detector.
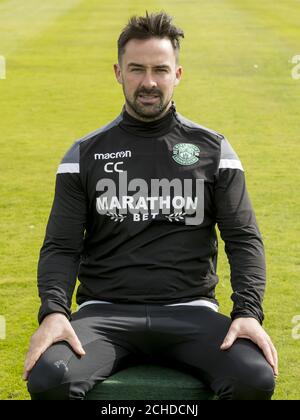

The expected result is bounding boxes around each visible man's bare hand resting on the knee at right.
[221,318,278,376]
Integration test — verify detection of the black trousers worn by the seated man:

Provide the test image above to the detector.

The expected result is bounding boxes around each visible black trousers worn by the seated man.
[28,304,275,400]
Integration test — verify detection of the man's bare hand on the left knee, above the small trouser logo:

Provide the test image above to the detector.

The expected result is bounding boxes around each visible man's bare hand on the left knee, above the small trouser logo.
[23,313,85,380]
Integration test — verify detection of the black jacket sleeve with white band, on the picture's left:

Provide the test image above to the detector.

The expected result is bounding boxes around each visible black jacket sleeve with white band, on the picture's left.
[37,142,87,323]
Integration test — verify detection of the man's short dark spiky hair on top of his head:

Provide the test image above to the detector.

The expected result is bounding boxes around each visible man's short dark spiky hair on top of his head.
[118,11,184,64]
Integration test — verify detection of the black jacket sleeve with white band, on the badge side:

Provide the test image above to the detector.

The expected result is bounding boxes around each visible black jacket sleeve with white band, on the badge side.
[214,138,266,324]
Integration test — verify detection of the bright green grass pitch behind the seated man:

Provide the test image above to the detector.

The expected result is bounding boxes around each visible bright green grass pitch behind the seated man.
[0,0,300,400]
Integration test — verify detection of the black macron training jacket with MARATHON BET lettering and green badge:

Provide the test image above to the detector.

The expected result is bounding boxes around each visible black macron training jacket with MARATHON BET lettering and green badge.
[38,102,265,323]
